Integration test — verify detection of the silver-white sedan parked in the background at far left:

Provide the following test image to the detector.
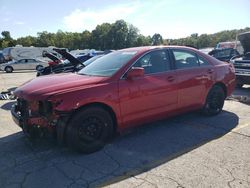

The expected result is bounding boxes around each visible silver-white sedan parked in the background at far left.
[0,59,48,73]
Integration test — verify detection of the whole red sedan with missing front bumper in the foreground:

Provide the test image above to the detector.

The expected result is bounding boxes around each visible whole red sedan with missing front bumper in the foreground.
[11,46,235,153]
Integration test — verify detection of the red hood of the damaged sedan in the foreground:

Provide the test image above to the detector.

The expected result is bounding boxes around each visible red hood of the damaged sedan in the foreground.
[14,73,107,101]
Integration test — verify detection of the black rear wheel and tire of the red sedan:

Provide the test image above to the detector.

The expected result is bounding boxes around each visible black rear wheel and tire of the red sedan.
[202,85,225,116]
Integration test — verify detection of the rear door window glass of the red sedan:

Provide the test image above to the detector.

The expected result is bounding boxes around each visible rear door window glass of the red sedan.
[173,49,199,69]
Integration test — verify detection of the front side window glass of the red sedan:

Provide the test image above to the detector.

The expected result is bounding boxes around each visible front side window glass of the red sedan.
[133,50,170,74]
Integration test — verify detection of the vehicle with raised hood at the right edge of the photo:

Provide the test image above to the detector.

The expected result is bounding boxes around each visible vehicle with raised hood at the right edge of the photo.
[230,32,250,88]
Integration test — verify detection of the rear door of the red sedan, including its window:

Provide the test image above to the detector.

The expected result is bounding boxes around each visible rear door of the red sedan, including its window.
[172,49,214,108]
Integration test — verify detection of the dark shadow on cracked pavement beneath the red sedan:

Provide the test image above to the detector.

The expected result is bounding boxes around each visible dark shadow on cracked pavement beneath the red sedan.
[0,111,239,187]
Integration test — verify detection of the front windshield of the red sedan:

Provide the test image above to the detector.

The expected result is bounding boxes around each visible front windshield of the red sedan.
[78,51,137,77]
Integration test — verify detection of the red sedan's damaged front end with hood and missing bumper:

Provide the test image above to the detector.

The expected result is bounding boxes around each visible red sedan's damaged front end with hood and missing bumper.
[11,73,105,142]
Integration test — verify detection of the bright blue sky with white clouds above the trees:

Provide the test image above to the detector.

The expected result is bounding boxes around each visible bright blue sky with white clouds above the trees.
[0,0,250,39]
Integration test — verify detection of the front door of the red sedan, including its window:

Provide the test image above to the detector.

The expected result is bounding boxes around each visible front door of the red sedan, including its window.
[119,50,178,125]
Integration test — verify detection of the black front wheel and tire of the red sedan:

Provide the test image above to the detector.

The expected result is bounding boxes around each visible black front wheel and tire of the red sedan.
[66,107,114,153]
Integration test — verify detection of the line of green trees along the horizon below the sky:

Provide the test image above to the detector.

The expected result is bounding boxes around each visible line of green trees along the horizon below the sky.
[0,20,250,50]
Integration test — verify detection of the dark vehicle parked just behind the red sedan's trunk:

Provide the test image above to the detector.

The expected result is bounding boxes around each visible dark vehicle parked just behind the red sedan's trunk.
[208,48,240,62]
